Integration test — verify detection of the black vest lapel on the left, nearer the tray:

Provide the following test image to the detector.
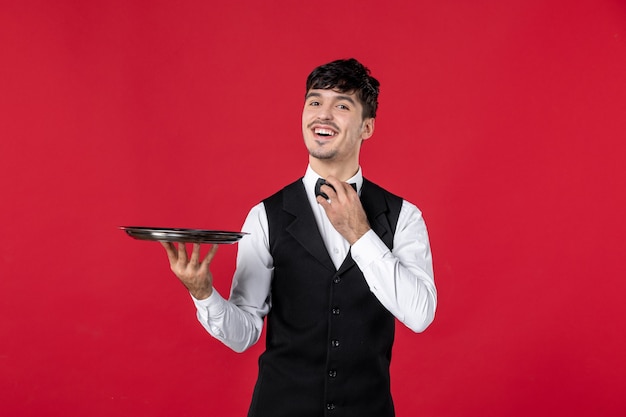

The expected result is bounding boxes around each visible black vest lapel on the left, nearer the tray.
[283,181,335,271]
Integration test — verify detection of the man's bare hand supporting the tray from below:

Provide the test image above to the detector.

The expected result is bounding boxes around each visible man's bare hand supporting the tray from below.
[161,242,218,300]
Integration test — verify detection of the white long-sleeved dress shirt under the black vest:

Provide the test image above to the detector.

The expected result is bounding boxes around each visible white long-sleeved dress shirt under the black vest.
[192,166,437,352]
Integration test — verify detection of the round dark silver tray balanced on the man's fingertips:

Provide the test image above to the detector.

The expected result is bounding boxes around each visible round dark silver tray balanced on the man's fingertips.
[120,226,248,245]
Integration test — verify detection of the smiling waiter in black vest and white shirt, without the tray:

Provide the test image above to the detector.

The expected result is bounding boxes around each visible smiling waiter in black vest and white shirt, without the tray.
[163,59,436,417]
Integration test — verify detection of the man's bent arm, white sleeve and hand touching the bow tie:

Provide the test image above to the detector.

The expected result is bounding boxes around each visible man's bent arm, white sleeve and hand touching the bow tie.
[317,176,437,332]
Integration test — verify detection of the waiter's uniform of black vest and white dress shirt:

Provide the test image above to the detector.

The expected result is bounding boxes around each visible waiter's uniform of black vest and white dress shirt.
[193,166,437,417]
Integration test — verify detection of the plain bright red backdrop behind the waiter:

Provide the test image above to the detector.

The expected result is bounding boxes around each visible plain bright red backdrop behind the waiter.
[0,0,626,417]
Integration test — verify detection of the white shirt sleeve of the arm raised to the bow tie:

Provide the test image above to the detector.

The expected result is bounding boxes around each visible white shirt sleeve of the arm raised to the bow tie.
[351,201,437,332]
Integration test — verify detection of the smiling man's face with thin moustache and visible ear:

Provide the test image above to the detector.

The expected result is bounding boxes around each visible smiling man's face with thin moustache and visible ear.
[302,89,374,164]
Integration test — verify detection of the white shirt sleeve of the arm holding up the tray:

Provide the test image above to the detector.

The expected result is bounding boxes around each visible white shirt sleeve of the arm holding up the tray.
[192,203,274,352]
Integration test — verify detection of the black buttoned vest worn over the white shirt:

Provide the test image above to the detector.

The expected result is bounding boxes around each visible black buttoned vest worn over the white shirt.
[248,179,402,417]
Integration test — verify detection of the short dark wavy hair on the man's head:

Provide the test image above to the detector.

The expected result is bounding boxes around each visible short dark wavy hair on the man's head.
[305,58,380,118]
